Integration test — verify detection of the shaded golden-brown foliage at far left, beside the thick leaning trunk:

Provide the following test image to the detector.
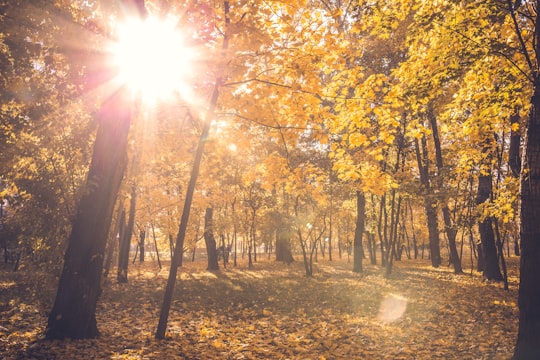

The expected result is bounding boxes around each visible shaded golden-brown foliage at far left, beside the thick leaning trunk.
[0,0,96,270]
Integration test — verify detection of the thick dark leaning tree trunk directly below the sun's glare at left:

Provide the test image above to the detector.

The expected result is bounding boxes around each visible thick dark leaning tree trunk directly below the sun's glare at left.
[45,89,132,339]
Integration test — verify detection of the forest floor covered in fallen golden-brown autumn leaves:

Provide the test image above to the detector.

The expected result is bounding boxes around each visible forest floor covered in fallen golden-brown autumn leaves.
[0,257,519,359]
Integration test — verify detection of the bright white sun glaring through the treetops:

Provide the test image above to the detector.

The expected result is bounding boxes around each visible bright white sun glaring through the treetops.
[110,16,194,102]
